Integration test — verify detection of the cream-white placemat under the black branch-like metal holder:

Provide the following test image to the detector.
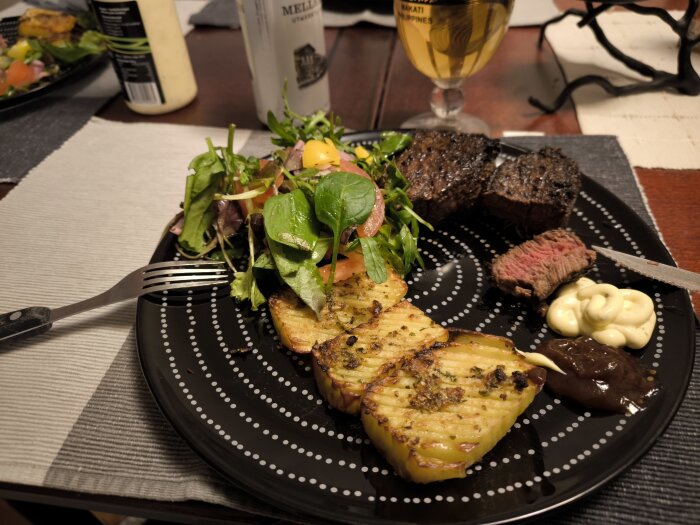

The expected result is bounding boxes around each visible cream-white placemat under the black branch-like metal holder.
[545,12,700,169]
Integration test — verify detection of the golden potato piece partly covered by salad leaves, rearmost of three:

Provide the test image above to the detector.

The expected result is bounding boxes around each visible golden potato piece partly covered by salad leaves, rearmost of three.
[269,269,408,353]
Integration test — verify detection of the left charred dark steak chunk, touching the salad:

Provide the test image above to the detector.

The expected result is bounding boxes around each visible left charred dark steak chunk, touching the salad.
[396,130,499,223]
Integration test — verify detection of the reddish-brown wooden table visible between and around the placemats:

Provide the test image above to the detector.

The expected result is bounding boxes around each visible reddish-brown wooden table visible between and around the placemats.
[0,0,700,523]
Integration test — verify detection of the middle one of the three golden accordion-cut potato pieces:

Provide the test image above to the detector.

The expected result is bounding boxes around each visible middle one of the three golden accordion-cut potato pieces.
[312,301,449,414]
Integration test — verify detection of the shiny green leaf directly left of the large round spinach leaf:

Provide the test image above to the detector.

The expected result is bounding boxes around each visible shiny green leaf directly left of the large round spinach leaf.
[263,190,318,252]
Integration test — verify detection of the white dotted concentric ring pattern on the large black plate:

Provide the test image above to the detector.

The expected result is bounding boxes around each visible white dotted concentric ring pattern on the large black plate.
[138,141,684,521]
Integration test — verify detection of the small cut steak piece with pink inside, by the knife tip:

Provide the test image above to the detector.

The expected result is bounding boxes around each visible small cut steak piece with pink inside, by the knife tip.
[491,230,596,308]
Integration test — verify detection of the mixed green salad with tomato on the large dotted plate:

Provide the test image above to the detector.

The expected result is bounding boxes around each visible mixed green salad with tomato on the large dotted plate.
[173,104,431,314]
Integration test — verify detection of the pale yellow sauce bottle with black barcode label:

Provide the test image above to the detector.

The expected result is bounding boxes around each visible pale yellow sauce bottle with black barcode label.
[91,0,197,115]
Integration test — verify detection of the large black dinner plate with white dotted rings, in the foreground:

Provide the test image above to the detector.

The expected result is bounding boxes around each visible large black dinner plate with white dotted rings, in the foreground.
[137,132,695,524]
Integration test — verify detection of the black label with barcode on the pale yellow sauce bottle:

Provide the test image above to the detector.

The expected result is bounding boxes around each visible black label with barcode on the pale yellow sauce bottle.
[92,0,165,104]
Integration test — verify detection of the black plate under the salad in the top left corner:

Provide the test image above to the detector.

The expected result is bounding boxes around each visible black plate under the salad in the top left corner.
[0,17,107,114]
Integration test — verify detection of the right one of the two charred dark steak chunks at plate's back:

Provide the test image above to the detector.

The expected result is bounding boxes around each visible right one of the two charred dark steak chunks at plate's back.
[481,148,581,234]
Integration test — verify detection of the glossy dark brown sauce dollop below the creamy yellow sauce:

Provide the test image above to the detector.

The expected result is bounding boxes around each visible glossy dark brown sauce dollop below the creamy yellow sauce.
[537,337,658,414]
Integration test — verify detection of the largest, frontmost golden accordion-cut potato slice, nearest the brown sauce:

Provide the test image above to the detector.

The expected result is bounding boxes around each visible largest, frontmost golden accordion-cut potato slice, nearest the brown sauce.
[361,332,546,483]
